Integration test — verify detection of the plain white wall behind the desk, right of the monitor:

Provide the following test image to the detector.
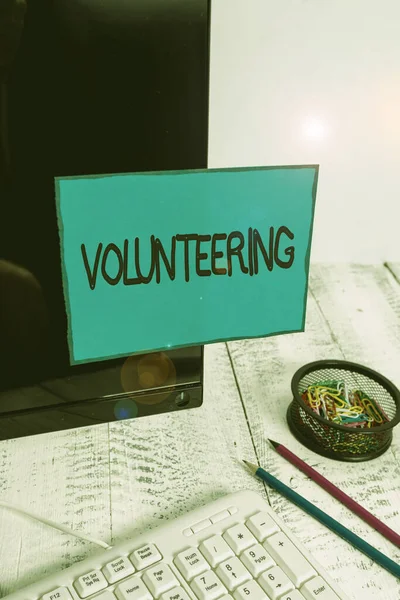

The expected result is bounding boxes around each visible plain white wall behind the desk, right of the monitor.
[209,0,400,262]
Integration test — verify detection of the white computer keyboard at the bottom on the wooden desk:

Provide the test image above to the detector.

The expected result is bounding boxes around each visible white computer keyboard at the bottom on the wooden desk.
[6,491,348,600]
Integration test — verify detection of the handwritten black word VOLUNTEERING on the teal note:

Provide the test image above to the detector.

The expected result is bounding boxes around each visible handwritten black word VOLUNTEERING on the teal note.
[81,226,295,290]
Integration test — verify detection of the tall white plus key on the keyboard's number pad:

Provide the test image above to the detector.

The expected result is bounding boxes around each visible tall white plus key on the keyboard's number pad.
[263,531,317,588]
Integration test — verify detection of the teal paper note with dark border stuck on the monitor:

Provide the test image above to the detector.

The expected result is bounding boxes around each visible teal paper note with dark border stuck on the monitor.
[56,166,318,364]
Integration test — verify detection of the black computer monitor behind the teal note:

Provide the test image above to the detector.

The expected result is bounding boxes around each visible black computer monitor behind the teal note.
[0,0,210,439]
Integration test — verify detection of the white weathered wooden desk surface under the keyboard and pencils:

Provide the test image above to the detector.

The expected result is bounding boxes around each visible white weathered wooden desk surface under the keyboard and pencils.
[0,264,400,600]
